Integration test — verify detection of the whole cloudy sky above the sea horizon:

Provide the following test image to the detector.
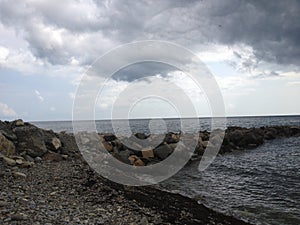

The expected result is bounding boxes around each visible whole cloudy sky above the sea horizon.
[0,0,300,121]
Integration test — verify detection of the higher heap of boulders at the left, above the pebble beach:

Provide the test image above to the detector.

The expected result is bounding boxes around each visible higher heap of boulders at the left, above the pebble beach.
[0,120,74,167]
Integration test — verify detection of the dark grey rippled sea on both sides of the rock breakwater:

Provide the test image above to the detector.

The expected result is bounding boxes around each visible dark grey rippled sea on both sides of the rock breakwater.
[32,116,300,225]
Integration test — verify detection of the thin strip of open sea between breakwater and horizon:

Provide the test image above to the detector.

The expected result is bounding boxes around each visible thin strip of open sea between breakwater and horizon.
[32,116,300,133]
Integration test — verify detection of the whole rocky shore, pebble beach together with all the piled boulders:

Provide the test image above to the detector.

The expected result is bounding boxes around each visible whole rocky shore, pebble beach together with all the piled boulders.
[0,120,300,225]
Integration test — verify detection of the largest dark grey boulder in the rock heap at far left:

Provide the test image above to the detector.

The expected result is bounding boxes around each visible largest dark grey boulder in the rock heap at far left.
[13,125,47,158]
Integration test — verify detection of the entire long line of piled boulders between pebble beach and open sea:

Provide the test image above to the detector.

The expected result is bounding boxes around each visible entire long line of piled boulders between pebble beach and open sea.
[0,120,300,170]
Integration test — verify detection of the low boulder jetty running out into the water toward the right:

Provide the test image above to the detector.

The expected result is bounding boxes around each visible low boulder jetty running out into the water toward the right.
[81,126,300,166]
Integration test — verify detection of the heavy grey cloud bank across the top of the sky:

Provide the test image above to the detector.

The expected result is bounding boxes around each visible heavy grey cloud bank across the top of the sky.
[0,0,300,77]
